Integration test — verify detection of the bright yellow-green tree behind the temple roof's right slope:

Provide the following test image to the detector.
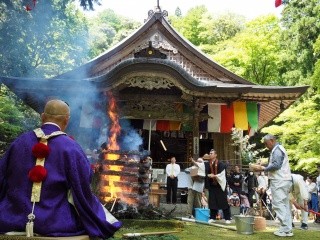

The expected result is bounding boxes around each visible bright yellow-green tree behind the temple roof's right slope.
[212,15,281,85]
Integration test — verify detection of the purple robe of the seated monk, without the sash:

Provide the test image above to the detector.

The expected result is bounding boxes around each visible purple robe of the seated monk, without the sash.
[0,126,121,238]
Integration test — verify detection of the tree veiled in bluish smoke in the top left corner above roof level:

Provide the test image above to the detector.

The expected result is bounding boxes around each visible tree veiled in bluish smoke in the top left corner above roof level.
[0,0,88,77]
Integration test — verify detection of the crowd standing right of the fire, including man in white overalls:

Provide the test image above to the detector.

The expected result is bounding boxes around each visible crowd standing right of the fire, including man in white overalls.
[179,134,320,237]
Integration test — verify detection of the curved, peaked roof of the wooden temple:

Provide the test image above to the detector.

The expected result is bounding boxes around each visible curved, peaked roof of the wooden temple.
[0,9,308,128]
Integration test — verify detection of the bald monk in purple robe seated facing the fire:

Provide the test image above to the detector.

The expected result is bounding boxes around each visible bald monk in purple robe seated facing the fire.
[0,100,122,238]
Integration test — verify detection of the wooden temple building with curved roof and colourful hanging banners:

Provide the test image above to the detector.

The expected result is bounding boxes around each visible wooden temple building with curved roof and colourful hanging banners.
[0,6,308,167]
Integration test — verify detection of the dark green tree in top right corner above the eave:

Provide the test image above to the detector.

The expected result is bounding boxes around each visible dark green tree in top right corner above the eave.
[280,0,320,85]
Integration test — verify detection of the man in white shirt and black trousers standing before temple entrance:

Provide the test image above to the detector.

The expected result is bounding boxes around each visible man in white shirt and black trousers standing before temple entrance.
[166,157,180,204]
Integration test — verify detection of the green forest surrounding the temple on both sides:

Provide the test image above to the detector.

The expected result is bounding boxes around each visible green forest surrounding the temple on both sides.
[0,0,320,176]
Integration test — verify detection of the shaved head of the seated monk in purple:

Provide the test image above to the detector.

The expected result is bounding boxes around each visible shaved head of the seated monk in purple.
[41,99,70,131]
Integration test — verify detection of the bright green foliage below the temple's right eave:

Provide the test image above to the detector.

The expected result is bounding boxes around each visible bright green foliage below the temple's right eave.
[262,94,320,173]
